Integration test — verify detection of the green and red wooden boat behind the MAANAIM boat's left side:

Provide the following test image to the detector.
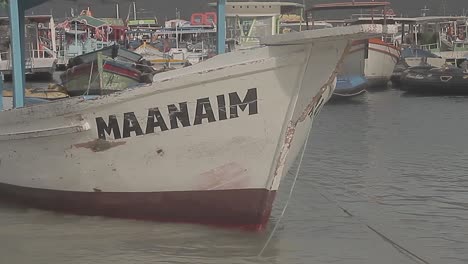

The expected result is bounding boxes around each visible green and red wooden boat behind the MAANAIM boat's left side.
[60,45,153,96]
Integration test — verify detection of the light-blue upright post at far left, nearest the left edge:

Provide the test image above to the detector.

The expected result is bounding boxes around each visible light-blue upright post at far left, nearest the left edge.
[9,0,26,108]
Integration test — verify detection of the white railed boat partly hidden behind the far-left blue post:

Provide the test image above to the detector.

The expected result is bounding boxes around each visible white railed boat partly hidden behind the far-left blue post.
[0,15,57,78]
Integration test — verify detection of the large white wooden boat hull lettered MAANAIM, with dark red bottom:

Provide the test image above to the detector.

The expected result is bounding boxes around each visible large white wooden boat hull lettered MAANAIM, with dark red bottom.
[0,25,382,228]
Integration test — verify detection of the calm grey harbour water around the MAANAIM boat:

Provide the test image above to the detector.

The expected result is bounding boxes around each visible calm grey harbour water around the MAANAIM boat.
[0,87,468,264]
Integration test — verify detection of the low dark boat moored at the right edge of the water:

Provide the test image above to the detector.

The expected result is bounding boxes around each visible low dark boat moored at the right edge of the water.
[401,66,468,95]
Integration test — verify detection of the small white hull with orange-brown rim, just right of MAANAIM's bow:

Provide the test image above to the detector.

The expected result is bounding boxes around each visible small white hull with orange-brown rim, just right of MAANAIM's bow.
[365,39,400,87]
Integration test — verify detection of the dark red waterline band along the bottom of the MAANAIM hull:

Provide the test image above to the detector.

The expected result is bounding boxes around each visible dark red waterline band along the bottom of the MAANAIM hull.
[0,183,276,230]
